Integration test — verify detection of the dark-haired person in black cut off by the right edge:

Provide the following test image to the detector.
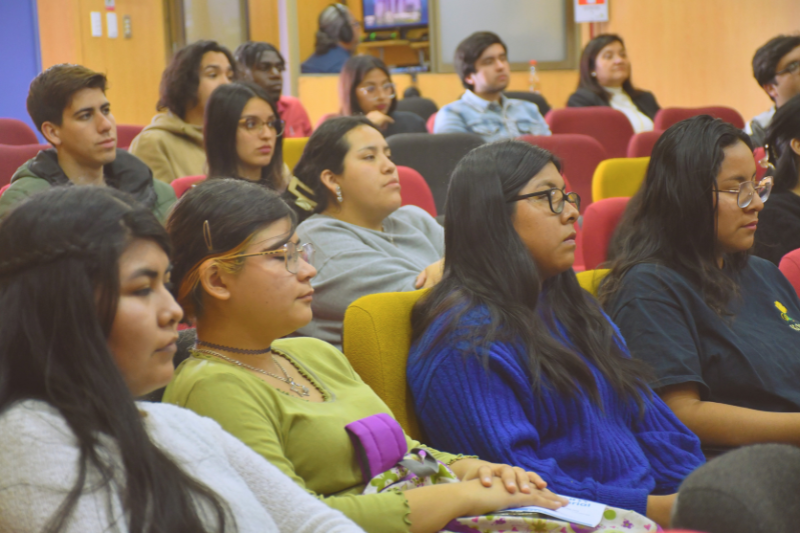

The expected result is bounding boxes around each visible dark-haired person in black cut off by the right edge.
[753,95,800,265]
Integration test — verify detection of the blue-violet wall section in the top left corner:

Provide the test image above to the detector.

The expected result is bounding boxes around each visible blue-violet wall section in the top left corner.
[0,0,42,139]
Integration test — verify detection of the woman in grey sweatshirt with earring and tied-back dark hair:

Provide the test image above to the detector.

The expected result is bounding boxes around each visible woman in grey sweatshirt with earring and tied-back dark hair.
[286,117,444,347]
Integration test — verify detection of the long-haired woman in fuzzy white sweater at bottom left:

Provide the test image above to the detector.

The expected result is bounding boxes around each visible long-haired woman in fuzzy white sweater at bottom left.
[0,187,361,533]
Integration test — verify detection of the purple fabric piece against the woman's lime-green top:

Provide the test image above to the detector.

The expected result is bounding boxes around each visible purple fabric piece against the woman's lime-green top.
[344,413,408,483]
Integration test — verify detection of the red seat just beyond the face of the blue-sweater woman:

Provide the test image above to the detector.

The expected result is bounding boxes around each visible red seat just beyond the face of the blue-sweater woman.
[519,133,607,213]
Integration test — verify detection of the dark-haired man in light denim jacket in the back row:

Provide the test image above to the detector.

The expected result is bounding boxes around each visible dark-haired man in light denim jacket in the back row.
[433,31,550,142]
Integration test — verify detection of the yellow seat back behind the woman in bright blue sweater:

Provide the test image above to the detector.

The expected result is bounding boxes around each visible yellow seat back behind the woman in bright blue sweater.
[342,290,427,440]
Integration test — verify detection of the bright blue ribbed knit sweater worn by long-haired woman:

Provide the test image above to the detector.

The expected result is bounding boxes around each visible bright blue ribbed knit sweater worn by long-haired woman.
[407,308,705,514]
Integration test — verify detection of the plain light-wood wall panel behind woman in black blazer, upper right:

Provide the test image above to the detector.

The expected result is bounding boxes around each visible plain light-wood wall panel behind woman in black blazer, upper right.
[597,0,800,120]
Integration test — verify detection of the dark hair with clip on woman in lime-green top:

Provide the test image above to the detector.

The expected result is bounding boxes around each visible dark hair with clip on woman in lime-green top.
[167,179,297,318]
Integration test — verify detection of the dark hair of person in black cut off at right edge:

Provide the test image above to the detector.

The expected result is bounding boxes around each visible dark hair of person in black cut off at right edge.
[765,94,800,192]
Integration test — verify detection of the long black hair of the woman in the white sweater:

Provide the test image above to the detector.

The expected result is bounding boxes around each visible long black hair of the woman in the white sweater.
[0,187,231,533]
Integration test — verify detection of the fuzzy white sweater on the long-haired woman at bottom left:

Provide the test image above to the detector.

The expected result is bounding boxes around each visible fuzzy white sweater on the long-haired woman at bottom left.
[0,400,362,533]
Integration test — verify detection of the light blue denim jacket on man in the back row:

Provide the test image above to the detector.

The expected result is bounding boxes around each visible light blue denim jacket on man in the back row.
[433,90,550,142]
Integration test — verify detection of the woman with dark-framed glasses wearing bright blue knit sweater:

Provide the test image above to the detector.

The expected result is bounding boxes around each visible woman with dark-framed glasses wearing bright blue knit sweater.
[408,141,704,526]
